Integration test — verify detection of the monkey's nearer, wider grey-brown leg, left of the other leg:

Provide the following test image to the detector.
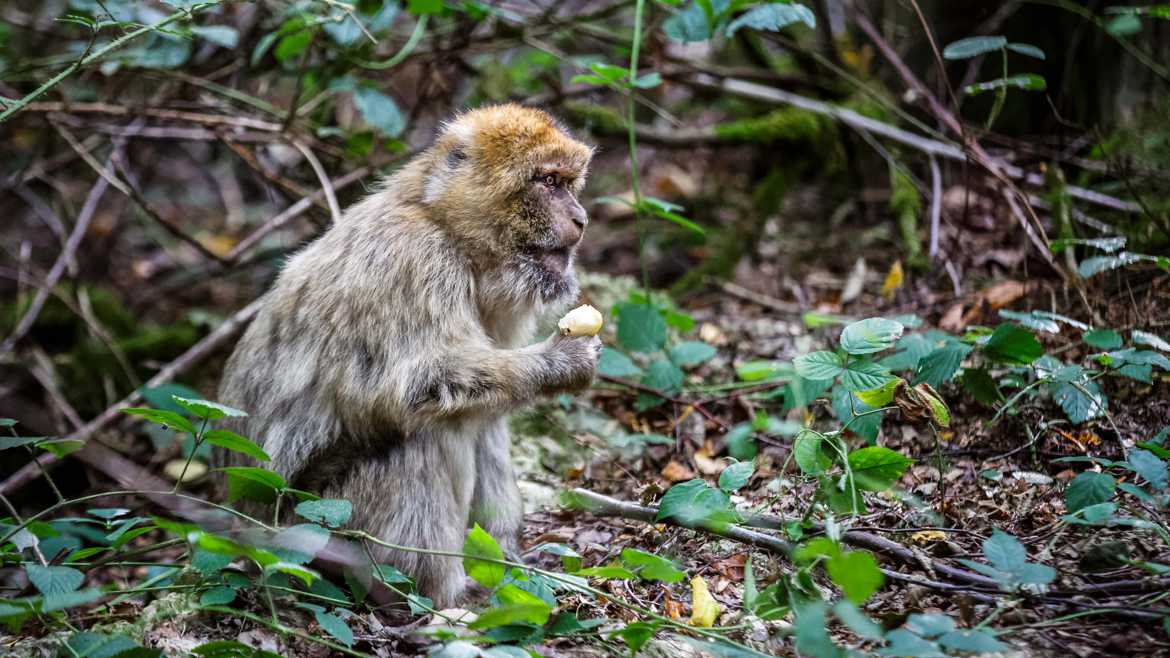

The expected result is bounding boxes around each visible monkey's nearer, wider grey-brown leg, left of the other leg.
[330,436,474,609]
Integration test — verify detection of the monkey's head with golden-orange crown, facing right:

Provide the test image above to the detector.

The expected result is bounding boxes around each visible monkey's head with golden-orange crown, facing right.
[422,104,593,301]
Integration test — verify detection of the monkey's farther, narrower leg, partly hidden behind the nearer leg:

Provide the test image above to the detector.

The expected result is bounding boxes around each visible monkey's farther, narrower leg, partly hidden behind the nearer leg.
[472,418,524,557]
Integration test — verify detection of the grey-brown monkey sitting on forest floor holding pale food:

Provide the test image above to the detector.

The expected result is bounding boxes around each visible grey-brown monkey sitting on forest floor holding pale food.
[216,104,600,609]
